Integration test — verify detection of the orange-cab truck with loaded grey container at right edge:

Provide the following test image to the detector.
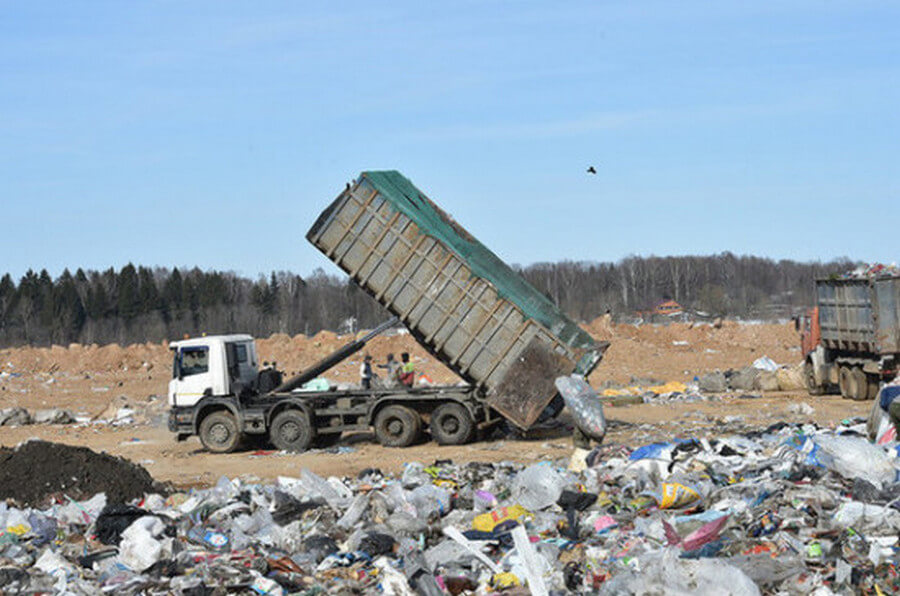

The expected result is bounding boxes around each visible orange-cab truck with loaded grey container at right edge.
[797,276,900,400]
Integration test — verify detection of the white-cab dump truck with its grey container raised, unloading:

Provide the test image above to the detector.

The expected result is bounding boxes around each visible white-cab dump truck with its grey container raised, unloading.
[169,171,609,452]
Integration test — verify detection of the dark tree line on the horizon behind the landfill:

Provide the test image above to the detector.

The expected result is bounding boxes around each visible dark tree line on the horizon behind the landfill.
[0,253,854,347]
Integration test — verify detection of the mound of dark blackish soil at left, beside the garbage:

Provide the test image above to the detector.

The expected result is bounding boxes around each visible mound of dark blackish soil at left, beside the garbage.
[0,441,165,506]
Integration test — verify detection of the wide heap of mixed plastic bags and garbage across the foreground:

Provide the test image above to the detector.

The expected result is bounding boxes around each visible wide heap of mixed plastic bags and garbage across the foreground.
[0,420,900,596]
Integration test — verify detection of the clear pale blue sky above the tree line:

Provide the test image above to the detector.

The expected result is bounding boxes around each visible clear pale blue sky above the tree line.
[0,0,900,277]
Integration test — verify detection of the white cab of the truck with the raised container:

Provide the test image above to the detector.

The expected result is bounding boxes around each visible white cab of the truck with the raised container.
[168,334,259,407]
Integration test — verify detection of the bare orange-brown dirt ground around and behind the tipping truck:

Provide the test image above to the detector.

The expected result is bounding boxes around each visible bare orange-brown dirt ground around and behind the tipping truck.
[0,320,871,486]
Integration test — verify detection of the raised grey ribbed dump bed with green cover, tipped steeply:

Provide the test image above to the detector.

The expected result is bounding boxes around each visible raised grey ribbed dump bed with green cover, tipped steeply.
[306,171,609,429]
